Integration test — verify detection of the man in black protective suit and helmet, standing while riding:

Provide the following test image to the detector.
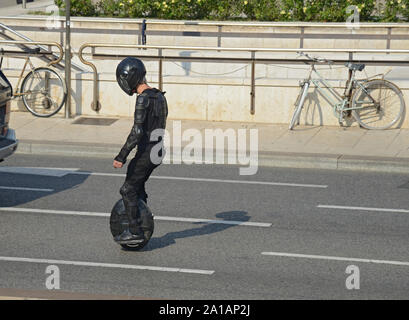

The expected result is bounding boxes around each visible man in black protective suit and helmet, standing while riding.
[113,57,168,244]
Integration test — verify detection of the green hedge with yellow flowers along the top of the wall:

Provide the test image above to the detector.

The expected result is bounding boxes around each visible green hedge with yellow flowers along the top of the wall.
[55,0,409,22]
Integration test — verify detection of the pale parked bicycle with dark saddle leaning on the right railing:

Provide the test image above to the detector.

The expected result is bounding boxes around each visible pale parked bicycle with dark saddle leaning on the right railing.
[289,52,405,130]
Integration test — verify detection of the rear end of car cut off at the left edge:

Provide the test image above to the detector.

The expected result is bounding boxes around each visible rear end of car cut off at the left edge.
[0,70,18,162]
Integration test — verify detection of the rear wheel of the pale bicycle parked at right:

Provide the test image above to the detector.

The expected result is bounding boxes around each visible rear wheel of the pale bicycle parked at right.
[352,79,405,130]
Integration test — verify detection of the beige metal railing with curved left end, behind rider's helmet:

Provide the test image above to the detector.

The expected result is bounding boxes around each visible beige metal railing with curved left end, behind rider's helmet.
[78,43,409,114]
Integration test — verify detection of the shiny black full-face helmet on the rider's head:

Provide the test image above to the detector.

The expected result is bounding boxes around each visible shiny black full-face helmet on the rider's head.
[116,57,146,96]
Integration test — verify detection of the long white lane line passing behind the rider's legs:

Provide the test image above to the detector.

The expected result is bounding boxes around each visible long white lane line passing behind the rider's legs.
[69,171,328,188]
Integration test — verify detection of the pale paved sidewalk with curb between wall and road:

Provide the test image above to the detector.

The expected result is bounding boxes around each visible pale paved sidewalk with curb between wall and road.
[10,112,409,173]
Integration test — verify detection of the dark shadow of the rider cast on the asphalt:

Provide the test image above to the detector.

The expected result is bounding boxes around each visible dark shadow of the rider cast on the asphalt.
[142,211,250,251]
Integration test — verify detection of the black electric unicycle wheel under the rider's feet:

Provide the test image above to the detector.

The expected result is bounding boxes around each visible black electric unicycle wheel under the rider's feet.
[109,199,154,250]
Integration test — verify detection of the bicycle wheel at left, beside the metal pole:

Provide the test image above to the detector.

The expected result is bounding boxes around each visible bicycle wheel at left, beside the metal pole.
[21,67,67,117]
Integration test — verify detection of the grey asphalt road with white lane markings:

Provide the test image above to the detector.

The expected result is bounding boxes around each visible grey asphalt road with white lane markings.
[0,155,409,299]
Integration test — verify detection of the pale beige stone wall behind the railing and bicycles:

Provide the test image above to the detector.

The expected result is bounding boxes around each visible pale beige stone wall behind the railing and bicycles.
[0,17,409,127]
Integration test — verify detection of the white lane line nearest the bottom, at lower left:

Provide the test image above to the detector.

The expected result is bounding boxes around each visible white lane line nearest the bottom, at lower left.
[0,256,214,275]
